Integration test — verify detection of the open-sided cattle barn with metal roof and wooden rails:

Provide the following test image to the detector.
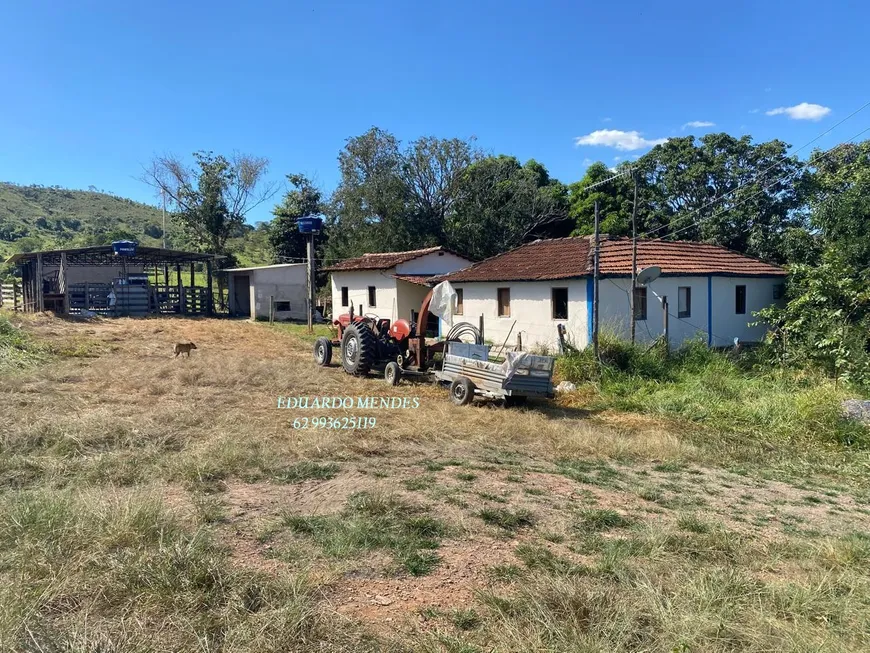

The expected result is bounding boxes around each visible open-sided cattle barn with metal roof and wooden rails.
[7,241,221,316]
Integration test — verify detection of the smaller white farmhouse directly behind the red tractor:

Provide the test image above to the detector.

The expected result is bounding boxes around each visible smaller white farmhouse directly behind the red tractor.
[325,247,472,330]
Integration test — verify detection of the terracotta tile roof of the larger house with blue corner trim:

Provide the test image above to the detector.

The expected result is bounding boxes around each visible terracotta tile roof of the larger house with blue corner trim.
[439,236,786,281]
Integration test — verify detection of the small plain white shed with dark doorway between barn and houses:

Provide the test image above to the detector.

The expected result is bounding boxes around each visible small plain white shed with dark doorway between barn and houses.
[225,263,308,320]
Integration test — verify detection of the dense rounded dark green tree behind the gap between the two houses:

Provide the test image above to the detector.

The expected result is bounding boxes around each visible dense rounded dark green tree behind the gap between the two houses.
[445,155,568,259]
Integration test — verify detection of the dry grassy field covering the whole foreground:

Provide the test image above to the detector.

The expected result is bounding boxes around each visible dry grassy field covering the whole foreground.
[0,316,870,652]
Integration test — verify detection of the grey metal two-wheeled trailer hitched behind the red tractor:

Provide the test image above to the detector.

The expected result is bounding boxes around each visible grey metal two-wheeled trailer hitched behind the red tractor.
[434,342,555,406]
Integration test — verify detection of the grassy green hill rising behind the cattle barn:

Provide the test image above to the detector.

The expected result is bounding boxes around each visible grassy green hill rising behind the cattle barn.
[0,182,163,256]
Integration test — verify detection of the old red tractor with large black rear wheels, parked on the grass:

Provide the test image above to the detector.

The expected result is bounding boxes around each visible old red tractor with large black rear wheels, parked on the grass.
[314,290,444,385]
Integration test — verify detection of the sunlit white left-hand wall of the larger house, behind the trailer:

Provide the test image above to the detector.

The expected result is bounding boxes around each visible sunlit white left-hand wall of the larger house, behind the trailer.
[451,279,589,351]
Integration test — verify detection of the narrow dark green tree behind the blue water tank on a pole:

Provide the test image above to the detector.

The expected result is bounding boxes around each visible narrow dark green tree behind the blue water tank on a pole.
[268,174,325,263]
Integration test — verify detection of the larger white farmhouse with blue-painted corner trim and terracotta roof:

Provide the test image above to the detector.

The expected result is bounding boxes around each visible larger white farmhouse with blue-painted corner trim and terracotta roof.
[434,236,786,349]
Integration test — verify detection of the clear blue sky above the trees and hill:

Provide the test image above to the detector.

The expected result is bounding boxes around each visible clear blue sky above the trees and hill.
[0,0,870,220]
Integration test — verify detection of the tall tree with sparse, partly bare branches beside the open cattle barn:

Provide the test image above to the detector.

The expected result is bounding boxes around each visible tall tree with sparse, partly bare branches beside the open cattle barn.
[143,151,276,255]
